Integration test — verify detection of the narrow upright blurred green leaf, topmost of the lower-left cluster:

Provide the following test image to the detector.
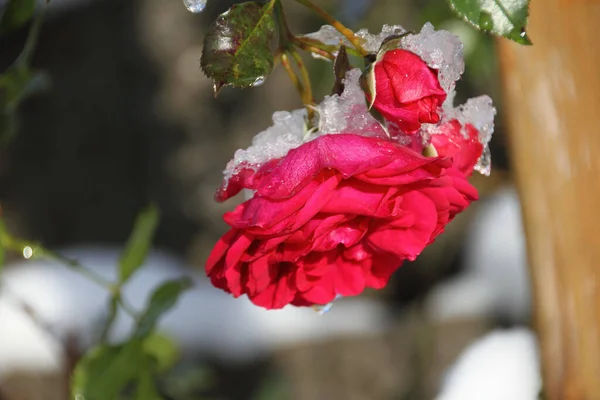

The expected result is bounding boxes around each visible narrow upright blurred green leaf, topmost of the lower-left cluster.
[119,205,158,283]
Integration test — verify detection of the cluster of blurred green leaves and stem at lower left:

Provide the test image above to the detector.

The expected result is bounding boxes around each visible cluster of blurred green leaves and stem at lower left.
[71,206,192,400]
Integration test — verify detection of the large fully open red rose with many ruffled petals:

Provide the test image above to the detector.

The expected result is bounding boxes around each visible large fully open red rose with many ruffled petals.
[206,134,477,309]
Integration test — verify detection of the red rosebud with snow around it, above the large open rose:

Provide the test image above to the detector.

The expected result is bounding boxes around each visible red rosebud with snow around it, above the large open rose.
[373,49,446,133]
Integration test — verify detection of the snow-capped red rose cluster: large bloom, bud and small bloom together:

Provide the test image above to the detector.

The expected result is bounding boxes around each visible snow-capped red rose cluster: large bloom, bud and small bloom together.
[206,24,495,309]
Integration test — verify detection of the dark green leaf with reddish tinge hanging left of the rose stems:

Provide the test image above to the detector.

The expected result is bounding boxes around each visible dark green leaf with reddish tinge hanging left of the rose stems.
[201,1,275,95]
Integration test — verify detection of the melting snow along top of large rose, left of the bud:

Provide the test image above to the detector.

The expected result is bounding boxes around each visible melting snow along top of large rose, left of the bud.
[224,68,385,182]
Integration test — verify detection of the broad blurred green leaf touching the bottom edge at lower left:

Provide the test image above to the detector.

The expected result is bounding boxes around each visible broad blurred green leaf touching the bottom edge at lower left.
[71,340,145,400]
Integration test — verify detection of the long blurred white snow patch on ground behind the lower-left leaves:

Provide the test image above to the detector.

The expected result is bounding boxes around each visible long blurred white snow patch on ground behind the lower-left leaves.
[0,247,391,376]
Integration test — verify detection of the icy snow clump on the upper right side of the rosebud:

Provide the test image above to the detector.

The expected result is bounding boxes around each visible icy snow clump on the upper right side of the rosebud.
[402,22,465,93]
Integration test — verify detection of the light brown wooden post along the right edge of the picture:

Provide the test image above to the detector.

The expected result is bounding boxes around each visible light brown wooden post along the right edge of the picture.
[500,0,600,400]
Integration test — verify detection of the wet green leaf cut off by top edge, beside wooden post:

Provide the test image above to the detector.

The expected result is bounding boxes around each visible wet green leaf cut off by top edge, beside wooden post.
[449,0,531,45]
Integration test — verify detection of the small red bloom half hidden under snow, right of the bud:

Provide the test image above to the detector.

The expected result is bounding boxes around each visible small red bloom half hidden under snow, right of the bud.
[431,119,483,176]
